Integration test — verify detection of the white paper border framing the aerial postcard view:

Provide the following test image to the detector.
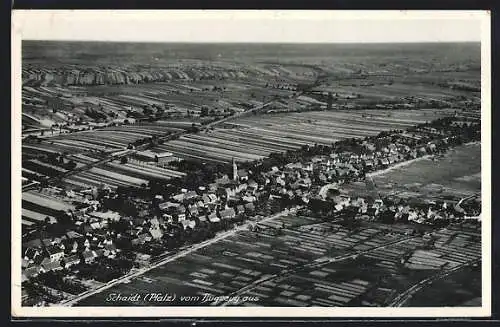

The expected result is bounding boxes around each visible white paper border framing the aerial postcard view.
[11,10,491,318]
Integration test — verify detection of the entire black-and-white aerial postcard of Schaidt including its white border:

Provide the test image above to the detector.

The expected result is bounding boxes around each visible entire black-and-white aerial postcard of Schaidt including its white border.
[11,10,491,317]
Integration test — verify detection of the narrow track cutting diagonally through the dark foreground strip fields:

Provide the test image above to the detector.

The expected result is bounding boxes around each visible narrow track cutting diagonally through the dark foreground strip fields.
[222,236,417,306]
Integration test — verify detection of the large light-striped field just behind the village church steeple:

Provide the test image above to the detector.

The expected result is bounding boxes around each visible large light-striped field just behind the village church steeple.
[159,109,453,162]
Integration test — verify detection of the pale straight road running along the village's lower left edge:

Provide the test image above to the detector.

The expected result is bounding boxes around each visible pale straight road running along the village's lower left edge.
[55,207,300,306]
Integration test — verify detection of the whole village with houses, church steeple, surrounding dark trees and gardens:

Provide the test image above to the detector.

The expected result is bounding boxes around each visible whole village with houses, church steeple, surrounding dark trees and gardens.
[22,112,481,305]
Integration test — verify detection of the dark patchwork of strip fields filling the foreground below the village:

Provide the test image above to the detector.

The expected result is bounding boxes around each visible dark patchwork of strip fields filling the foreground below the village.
[78,215,481,306]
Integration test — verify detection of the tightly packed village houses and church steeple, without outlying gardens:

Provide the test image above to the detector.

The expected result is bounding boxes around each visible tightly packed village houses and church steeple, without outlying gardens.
[19,116,480,304]
